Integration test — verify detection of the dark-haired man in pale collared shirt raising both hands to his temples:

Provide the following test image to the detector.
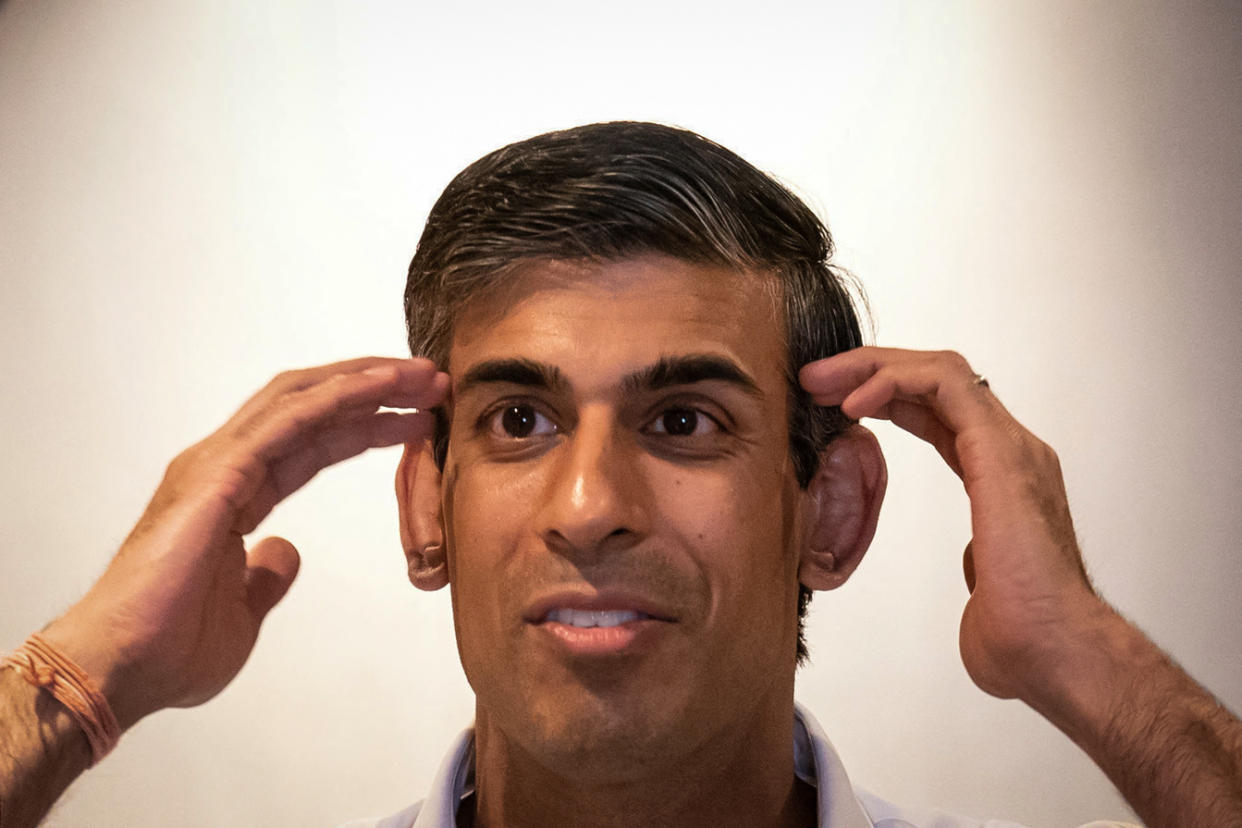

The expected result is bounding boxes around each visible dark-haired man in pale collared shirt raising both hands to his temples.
[0,124,1242,828]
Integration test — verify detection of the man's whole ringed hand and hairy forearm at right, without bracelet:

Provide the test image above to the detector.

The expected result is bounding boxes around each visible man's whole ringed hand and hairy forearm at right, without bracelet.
[800,348,1242,828]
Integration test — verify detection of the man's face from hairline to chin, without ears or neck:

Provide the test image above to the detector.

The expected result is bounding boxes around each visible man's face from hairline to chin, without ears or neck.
[442,256,805,772]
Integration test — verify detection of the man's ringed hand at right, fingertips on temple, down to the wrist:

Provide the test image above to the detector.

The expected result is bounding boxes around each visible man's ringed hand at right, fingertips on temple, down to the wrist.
[800,348,1112,700]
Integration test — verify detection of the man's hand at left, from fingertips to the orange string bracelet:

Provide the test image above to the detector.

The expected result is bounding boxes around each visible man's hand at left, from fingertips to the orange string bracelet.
[35,358,448,729]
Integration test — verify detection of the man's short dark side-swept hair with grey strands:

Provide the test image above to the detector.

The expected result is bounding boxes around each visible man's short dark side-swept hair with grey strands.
[405,122,862,663]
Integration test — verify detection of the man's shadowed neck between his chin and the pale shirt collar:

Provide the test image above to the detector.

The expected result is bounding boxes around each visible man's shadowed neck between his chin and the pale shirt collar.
[460,691,816,828]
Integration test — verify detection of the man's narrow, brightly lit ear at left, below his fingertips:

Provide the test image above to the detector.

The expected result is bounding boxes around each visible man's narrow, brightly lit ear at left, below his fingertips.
[396,439,448,590]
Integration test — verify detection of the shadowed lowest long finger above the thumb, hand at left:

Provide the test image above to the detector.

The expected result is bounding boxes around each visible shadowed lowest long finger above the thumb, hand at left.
[233,411,435,535]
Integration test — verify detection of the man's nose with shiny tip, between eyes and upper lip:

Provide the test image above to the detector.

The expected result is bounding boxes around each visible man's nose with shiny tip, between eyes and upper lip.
[538,410,647,555]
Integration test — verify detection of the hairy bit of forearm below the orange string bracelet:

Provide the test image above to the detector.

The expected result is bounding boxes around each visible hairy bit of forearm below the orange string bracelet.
[0,669,91,828]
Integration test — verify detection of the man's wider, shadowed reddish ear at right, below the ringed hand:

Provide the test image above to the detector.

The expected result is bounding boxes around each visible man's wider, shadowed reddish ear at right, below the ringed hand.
[797,426,888,590]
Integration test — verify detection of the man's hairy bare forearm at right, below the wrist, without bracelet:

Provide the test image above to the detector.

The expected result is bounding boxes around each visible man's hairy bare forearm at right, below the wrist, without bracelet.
[1027,610,1242,828]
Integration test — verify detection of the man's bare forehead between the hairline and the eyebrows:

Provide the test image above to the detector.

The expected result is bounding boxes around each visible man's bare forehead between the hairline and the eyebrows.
[447,254,786,385]
